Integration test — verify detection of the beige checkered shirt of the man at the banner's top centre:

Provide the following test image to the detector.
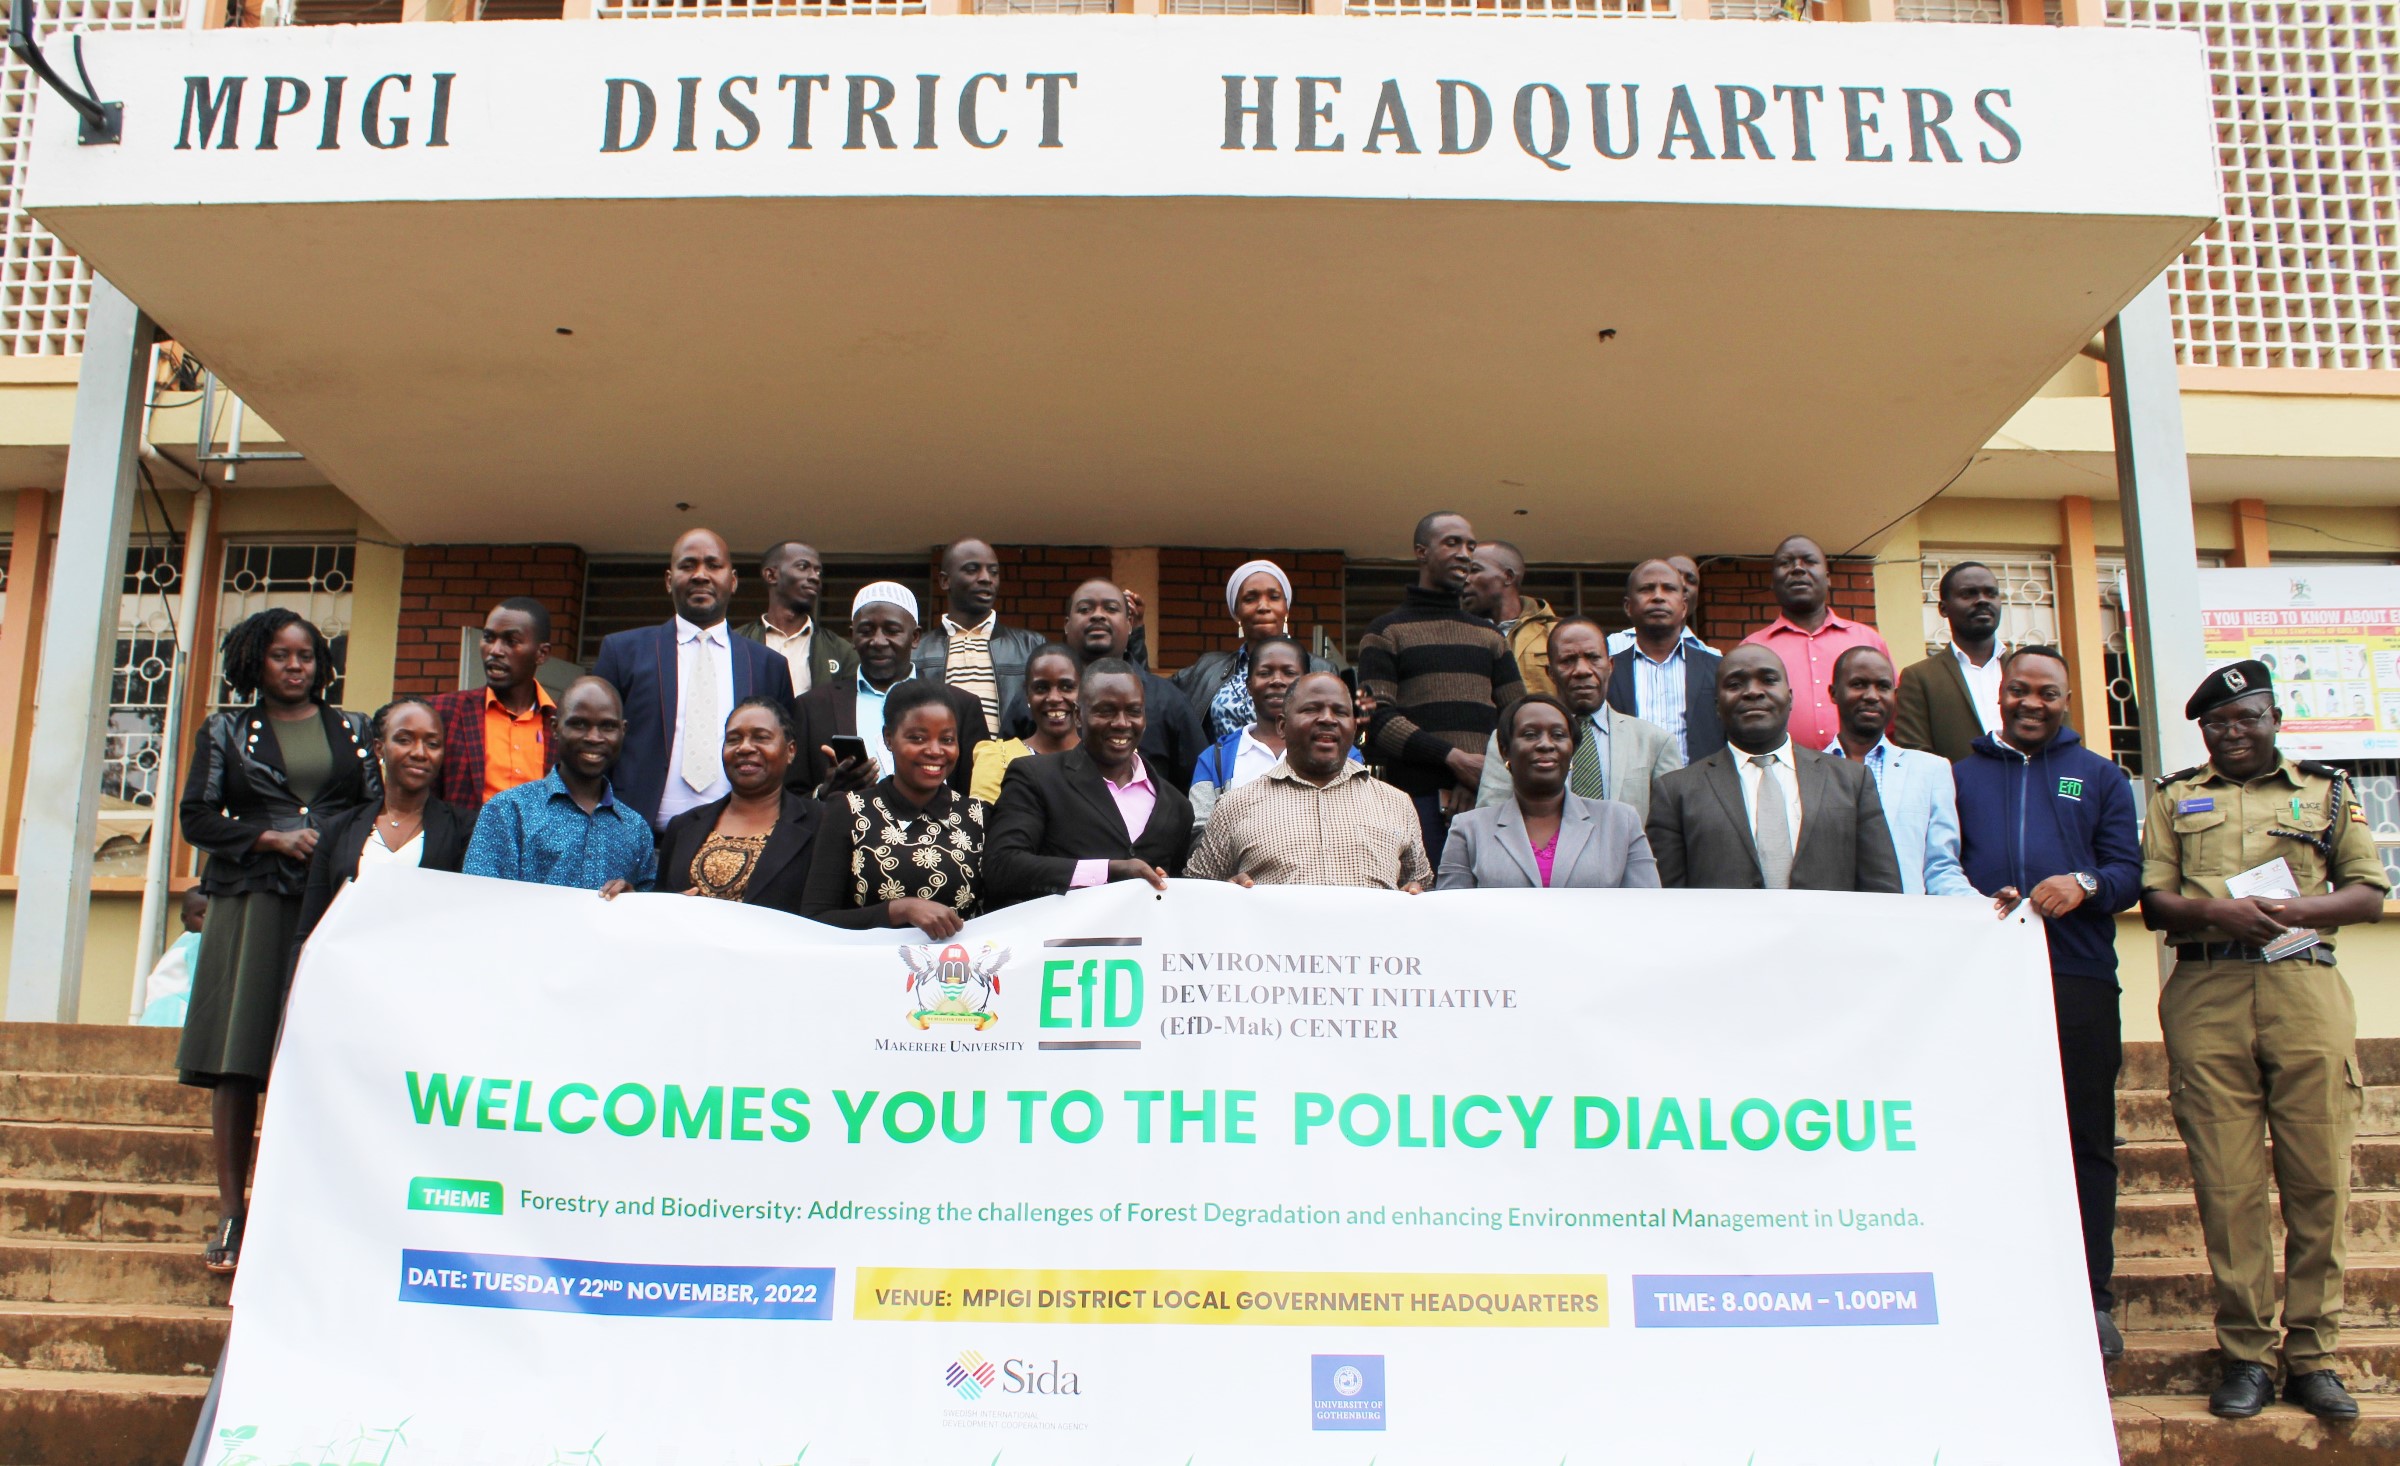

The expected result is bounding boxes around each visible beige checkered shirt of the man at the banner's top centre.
[1183,758,1433,890]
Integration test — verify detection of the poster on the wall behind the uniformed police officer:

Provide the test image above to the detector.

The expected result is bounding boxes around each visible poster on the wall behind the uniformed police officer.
[2201,566,2400,758]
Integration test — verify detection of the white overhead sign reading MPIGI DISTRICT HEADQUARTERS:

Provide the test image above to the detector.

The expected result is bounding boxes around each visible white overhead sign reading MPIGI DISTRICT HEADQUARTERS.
[31,17,2215,218]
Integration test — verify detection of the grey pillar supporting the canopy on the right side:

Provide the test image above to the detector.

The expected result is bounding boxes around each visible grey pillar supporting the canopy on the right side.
[2107,276,2208,780]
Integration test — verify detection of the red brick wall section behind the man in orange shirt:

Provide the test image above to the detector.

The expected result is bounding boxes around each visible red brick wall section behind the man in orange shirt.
[391,545,583,693]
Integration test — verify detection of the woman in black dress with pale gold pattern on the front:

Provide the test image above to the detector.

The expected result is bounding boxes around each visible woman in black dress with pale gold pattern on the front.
[799,679,984,941]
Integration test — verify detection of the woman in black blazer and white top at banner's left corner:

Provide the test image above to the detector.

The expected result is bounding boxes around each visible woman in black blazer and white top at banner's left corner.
[286,698,475,959]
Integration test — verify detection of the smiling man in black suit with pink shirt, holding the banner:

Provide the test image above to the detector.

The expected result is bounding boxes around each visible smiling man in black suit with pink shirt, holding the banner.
[984,657,1193,907]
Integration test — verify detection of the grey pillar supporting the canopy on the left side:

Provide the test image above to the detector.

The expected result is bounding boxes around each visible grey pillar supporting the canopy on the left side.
[7,276,157,1022]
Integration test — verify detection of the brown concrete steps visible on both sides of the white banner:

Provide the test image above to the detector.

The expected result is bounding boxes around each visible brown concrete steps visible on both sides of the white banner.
[0,1025,2400,1466]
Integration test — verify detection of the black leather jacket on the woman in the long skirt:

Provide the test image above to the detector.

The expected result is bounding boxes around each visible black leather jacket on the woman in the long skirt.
[180,705,384,895]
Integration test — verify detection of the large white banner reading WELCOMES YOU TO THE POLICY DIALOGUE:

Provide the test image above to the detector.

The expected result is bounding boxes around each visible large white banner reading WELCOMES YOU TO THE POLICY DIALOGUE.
[209,871,2117,1466]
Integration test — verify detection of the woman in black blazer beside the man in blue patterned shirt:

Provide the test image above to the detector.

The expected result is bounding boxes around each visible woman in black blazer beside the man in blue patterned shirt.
[658,698,818,917]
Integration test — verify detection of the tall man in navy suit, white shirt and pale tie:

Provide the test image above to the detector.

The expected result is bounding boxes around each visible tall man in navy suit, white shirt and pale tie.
[593,530,792,828]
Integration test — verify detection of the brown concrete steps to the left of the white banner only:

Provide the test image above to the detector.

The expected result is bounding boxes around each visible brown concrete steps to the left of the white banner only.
[0,1022,218,1466]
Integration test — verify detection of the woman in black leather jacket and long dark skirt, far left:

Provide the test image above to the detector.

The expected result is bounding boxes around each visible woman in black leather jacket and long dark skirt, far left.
[175,607,384,1272]
